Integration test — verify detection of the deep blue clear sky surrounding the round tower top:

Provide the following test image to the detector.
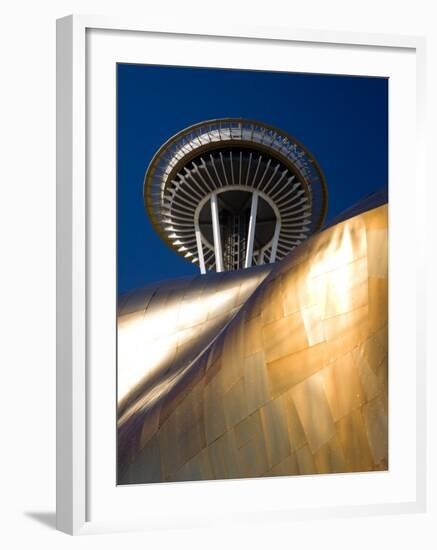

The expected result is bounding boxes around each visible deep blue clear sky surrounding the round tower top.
[117,64,388,292]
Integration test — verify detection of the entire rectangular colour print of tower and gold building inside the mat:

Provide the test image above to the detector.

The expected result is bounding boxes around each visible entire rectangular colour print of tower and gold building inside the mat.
[116,64,389,485]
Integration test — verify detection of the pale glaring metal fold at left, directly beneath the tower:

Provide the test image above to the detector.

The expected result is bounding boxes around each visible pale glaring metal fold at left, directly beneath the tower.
[117,266,271,420]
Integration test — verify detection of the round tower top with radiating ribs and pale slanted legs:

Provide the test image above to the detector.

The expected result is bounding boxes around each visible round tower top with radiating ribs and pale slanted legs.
[144,118,328,273]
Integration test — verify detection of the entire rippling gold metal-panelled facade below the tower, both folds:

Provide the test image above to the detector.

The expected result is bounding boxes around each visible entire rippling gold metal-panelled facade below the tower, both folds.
[118,205,388,484]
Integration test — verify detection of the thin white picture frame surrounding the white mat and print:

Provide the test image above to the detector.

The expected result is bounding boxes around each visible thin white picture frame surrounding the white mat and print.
[56,15,427,534]
